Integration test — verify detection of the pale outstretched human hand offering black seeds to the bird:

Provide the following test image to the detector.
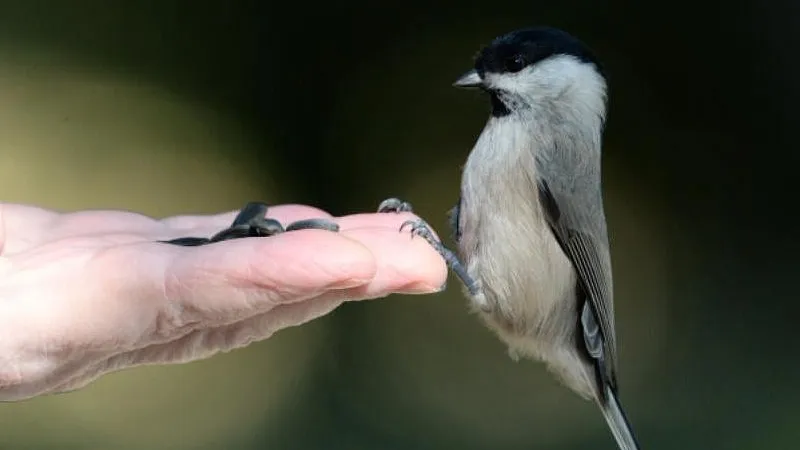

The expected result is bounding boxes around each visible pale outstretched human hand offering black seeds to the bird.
[0,204,447,401]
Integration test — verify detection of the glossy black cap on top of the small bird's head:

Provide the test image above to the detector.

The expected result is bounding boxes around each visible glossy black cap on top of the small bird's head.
[475,27,605,77]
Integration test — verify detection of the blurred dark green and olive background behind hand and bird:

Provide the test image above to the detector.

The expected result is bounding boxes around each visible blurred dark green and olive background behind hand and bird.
[0,0,800,450]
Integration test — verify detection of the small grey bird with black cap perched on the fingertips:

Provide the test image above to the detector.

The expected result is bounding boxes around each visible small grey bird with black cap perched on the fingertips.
[378,27,639,450]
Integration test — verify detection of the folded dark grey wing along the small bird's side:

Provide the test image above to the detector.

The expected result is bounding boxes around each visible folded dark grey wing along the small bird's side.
[537,178,617,388]
